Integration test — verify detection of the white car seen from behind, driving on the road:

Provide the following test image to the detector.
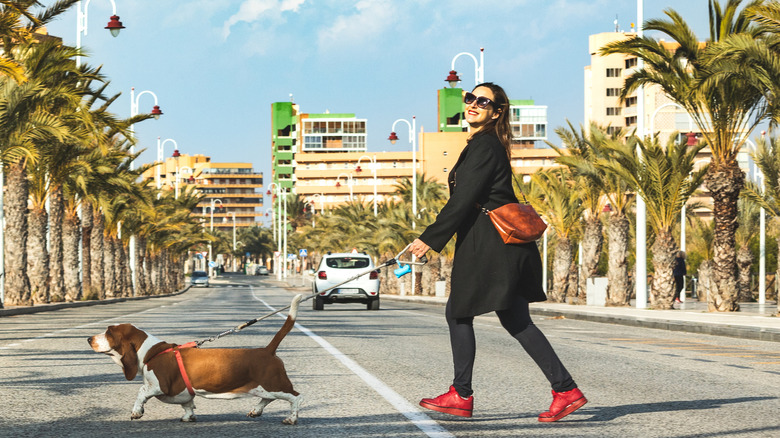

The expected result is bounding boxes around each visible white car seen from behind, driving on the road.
[312,252,379,310]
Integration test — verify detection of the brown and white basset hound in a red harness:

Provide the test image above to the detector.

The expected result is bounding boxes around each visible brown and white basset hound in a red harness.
[88,294,303,424]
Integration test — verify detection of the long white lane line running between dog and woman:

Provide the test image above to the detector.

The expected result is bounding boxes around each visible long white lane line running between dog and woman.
[250,286,454,438]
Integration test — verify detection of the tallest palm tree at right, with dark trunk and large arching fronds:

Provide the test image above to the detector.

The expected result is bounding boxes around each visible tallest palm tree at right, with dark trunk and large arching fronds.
[601,0,771,311]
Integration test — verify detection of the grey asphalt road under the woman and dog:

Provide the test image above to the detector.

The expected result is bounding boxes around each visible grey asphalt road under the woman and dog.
[0,277,780,437]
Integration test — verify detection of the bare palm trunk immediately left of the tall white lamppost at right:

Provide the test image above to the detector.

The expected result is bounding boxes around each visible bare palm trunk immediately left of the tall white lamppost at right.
[606,213,631,306]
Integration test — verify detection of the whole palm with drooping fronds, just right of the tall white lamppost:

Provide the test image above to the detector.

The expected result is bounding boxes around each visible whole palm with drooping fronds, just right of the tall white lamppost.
[596,136,708,309]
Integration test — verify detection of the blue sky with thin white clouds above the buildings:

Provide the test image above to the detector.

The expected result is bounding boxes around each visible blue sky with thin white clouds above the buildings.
[44,0,712,190]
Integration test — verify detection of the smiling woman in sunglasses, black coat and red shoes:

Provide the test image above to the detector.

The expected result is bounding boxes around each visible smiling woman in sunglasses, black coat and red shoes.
[410,83,587,422]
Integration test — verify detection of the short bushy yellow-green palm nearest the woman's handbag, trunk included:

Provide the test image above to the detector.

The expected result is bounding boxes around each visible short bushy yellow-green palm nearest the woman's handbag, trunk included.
[525,169,583,303]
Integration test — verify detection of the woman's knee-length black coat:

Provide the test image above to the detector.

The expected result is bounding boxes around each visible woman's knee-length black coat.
[420,133,547,318]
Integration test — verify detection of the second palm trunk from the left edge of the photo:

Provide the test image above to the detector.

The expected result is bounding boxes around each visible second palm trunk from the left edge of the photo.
[27,207,50,304]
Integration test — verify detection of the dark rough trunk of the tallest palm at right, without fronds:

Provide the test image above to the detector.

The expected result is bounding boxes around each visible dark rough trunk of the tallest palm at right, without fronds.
[705,161,745,312]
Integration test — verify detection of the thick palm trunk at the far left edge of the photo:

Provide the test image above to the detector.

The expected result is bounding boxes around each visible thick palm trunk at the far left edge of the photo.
[3,162,33,306]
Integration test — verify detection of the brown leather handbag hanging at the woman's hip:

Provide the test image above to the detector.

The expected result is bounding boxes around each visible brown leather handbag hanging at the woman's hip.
[480,202,547,244]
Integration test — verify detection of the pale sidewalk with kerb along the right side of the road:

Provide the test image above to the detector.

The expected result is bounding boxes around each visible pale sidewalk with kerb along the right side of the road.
[382,294,780,342]
